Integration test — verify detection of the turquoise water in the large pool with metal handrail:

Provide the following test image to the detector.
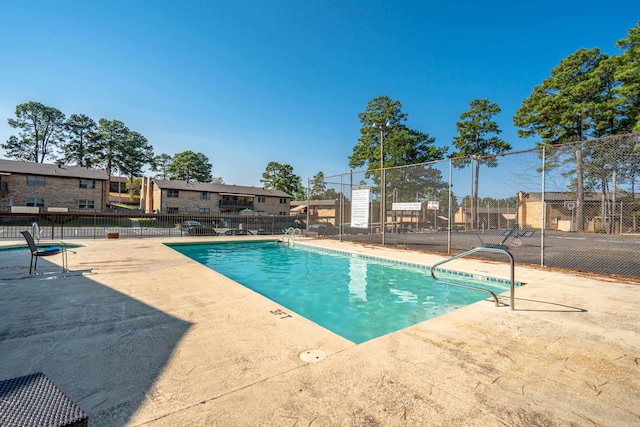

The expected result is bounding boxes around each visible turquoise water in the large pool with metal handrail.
[169,242,508,343]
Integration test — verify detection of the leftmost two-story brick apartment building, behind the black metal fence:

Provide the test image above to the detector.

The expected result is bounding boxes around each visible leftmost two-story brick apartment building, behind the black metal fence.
[0,159,109,212]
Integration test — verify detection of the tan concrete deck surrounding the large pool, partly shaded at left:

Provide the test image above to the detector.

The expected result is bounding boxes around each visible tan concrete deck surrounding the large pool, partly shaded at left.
[0,237,640,426]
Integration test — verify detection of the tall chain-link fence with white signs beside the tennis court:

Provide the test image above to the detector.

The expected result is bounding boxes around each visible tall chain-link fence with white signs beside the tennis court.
[306,134,640,278]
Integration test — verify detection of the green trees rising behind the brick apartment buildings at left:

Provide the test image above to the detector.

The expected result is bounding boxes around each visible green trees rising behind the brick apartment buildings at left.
[0,101,304,197]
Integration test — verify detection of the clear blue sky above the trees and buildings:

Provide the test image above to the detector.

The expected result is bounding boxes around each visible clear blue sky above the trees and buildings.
[0,0,640,186]
